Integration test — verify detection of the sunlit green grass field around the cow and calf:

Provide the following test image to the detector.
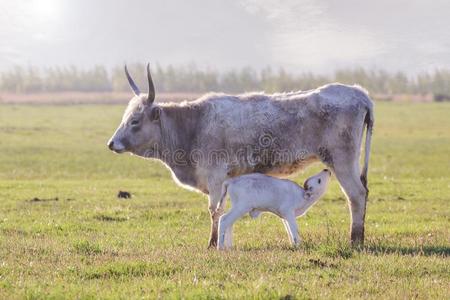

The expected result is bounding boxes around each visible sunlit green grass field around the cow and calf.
[0,103,450,299]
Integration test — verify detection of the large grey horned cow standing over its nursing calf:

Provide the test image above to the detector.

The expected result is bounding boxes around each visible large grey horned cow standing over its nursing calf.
[107,65,374,248]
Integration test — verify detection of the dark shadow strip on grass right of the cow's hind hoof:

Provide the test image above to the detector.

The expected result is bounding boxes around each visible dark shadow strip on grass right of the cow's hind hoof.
[364,245,450,257]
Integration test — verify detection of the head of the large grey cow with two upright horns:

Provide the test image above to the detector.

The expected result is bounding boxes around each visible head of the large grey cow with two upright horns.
[108,65,161,157]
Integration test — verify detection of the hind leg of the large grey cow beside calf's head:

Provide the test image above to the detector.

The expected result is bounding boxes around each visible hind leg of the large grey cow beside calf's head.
[331,153,368,246]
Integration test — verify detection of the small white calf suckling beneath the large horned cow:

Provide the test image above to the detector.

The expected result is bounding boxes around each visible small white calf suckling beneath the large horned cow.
[217,169,331,250]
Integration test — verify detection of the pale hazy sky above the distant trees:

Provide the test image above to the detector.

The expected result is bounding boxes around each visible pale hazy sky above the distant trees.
[0,0,450,73]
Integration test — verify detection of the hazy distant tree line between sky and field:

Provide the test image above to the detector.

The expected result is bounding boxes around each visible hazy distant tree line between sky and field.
[0,64,450,98]
